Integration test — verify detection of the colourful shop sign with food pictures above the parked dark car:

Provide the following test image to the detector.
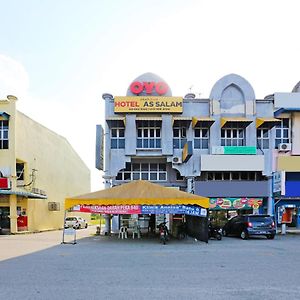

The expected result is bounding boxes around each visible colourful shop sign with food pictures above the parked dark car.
[209,198,263,210]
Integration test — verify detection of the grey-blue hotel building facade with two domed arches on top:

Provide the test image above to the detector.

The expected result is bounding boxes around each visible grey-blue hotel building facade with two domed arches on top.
[96,73,280,227]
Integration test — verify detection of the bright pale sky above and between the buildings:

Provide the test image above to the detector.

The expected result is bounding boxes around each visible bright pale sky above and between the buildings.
[0,0,300,191]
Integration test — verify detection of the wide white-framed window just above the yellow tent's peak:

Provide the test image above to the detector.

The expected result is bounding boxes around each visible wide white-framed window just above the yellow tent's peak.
[116,163,167,181]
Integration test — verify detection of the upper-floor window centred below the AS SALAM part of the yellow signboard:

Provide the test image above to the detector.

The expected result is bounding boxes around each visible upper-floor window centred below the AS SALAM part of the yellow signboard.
[137,120,161,149]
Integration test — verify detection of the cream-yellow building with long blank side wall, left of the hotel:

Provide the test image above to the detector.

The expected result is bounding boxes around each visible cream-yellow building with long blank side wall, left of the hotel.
[0,96,90,233]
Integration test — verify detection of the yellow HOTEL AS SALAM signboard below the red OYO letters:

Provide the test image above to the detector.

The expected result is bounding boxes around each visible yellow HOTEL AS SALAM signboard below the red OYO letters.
[114,96,183,113]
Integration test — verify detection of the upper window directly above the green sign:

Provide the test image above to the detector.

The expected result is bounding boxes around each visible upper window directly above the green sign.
[221,124,246,146]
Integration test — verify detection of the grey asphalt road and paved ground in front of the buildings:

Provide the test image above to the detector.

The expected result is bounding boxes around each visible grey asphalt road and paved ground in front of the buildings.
[0,228,300,300]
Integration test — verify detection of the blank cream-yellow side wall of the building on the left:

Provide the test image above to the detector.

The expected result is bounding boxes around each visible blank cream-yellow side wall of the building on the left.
[16,112,90,231]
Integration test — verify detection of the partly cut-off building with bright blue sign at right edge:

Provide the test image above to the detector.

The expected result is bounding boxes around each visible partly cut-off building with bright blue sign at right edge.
[272,83,300,227]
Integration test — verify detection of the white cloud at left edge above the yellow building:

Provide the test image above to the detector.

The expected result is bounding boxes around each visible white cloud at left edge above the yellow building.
[0,54,29,98]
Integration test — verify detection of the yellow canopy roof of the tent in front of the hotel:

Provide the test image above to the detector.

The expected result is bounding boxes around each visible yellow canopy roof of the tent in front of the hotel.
[65,180,209,210]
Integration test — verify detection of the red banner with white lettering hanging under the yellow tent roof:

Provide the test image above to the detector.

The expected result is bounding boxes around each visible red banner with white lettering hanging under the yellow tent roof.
[73,205,141,215]
